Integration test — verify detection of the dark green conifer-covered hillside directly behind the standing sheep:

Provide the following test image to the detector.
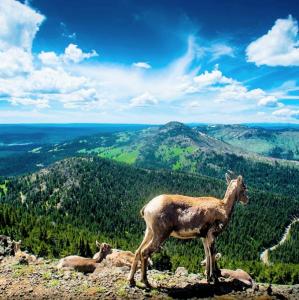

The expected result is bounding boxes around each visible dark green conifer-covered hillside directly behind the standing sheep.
[0,156,299,282]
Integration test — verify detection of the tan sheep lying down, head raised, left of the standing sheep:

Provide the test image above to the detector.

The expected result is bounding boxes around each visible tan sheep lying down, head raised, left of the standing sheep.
[57,243,111,273]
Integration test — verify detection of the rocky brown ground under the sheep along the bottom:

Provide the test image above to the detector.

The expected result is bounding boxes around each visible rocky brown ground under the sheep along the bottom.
[0,257,299,300]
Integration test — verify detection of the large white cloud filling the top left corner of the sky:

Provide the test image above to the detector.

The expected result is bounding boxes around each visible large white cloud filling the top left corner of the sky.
[0,0,45,52]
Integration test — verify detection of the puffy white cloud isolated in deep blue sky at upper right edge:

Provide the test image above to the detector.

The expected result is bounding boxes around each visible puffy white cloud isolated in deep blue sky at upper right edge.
[246,16,299,66]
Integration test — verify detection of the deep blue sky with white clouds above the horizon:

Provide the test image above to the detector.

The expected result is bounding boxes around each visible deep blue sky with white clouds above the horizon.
[0,0,299,124]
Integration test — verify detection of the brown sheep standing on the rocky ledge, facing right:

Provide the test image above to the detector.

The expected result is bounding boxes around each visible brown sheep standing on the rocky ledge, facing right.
[128,174,248,285]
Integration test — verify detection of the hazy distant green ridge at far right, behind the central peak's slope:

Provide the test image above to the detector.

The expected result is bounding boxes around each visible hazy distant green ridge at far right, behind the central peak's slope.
[197,125,299,160]
